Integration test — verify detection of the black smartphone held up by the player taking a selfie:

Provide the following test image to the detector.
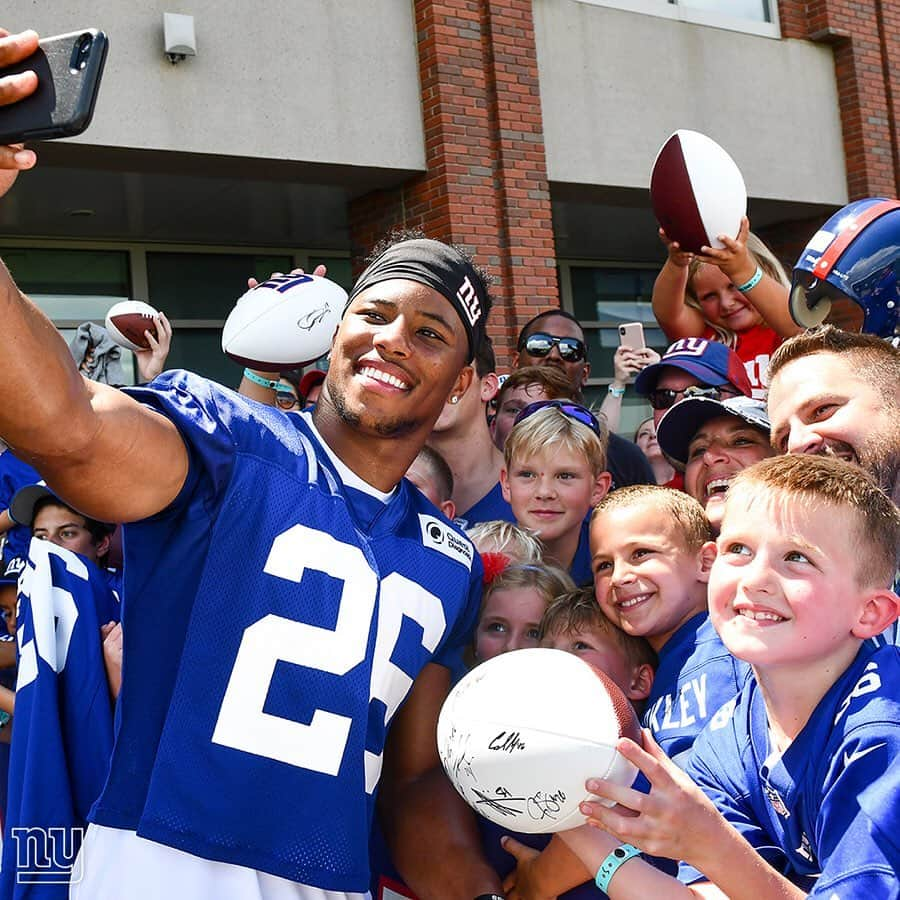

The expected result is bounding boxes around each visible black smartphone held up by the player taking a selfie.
[0,28,109,144]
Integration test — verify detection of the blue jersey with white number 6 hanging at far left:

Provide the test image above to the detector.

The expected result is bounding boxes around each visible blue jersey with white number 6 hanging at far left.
[0,540,119,900]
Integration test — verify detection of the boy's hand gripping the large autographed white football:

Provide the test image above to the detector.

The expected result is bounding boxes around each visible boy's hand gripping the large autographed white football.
[581,729,729,863]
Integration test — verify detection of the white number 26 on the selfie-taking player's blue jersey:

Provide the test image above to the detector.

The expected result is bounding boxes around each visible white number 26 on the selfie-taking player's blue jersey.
[212,525,446,792]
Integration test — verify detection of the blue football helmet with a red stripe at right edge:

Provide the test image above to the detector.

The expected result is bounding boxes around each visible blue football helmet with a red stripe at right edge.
[790,197,900,340]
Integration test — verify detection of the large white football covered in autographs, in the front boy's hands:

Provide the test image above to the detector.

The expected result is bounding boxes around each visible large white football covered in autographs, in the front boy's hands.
[437,648,640,834]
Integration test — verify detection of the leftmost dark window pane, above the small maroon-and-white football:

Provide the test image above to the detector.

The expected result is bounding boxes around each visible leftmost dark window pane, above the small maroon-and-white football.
[0,246,131,296]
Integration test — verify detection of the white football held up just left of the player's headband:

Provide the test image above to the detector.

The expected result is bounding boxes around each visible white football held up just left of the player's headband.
[222,275,347,371]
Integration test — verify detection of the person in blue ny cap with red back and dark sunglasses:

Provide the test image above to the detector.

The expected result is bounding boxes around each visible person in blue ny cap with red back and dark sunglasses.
[634,338,753,428]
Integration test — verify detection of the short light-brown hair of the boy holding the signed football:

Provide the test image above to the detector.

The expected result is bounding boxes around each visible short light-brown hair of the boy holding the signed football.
[725,453,900,588]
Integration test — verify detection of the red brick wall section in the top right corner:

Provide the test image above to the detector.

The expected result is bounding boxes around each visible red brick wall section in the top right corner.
[778,0,900,200]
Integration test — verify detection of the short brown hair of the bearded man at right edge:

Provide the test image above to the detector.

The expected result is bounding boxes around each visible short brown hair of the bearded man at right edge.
[768,325,900,409]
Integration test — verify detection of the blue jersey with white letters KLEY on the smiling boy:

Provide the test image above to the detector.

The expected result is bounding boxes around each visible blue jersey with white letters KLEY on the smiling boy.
[643,612,751,768]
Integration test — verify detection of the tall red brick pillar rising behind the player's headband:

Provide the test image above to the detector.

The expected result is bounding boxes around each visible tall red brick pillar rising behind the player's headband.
[350,0,559,370]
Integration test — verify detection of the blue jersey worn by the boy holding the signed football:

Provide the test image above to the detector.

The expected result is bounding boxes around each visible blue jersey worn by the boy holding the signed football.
[679,644,900,900]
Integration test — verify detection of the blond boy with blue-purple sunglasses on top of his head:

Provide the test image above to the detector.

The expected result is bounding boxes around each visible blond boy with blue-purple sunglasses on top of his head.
[500,400,611,585]
